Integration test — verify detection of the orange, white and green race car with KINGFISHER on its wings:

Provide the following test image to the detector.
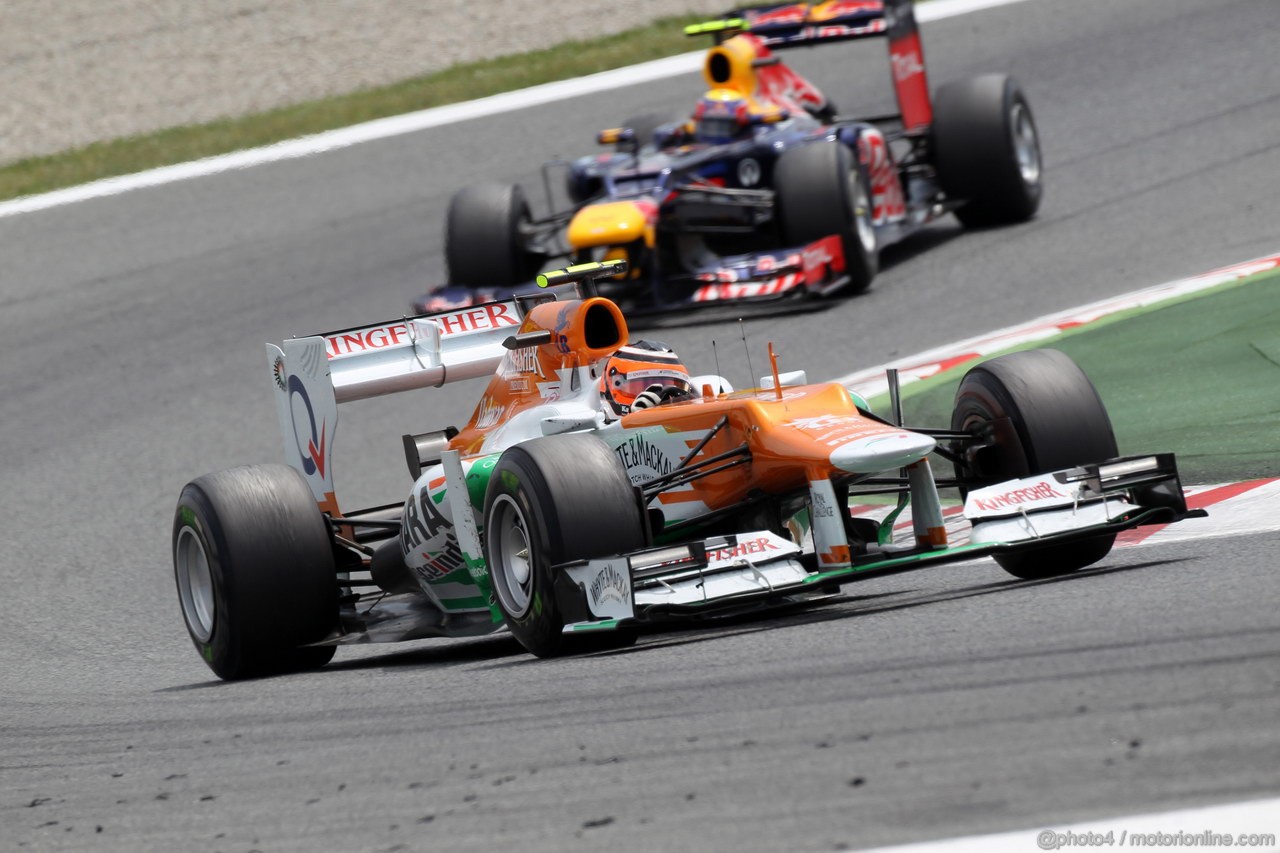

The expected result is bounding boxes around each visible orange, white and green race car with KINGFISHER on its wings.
[173,261,1203,679]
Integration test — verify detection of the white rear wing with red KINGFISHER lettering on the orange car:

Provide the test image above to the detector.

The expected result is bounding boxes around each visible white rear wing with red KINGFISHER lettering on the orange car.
[266,295,524,515]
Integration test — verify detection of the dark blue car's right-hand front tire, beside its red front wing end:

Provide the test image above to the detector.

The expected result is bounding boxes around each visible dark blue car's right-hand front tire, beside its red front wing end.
[773,142,879,293]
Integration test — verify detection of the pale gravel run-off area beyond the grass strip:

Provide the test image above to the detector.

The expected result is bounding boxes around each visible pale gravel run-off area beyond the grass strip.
[0,0,732,164]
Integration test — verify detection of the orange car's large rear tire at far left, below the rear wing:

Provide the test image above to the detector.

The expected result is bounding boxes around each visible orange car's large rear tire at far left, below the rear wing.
[173,465,338,680]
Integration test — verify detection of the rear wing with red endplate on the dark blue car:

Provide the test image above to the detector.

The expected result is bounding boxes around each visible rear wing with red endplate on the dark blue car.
[685,0,933,131]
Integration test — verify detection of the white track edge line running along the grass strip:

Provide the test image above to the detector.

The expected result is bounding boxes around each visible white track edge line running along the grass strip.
[0,0,1025,218]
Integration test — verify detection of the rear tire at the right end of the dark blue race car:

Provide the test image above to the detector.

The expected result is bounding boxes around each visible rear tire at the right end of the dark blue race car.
[933,74,1043,228]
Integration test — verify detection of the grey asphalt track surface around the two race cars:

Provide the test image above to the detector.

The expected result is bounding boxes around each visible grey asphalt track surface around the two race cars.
[0,0,1280,850]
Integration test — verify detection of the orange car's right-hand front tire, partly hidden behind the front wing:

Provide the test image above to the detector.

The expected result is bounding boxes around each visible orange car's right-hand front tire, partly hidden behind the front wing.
[951,350,1119,580]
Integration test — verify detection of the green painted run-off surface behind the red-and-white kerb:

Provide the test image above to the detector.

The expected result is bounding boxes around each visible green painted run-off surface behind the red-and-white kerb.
[872,273,1280,483]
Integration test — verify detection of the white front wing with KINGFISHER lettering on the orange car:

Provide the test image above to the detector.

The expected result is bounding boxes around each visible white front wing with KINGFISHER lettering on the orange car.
[556,455,1206,631]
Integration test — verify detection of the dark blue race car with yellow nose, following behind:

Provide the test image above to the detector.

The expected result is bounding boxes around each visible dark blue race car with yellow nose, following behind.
[415,0,1042,314]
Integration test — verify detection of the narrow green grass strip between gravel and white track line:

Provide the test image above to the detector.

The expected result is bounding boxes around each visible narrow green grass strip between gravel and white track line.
[0,17,704,200]
